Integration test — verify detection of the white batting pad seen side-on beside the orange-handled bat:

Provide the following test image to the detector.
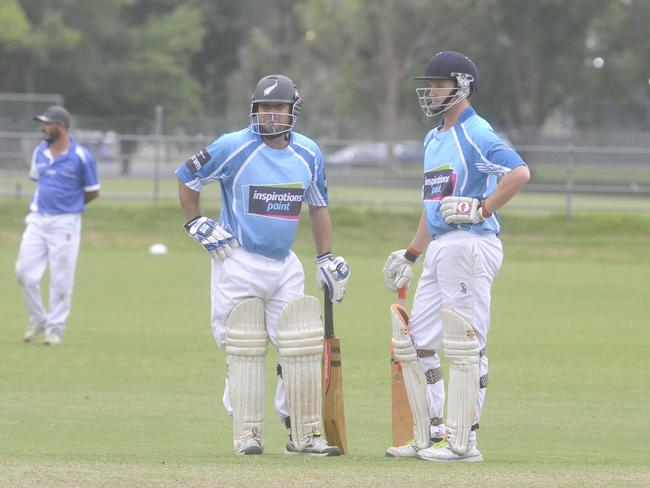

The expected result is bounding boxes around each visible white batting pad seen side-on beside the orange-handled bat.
[390,304,431,449]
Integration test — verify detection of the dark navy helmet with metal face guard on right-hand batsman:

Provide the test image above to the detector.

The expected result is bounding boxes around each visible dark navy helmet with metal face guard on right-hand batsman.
[415,51,479,117]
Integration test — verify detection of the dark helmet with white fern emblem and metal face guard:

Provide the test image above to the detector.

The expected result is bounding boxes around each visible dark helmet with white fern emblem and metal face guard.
[249,75,300,137]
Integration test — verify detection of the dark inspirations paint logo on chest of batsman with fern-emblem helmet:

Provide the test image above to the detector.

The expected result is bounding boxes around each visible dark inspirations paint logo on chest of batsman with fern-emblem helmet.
[248,185,305,220]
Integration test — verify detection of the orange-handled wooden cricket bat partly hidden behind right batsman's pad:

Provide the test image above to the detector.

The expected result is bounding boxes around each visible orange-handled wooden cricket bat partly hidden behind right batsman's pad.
[390,287,413,446]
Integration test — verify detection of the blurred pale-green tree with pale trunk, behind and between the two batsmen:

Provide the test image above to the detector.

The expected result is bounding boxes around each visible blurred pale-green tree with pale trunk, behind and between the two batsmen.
[292,0,487,141]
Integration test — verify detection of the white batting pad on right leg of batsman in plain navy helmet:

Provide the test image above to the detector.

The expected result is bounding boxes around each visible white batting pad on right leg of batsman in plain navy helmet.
[442,307,480,455]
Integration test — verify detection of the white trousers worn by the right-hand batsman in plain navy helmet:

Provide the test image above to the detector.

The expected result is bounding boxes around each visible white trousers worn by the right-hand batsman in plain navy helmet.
[409,230,503,430]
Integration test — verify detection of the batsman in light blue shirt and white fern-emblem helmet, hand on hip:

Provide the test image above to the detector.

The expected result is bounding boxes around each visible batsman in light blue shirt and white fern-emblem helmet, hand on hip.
[176,75,350,456]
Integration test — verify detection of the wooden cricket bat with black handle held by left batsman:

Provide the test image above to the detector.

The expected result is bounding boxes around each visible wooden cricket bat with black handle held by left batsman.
[323,290,348,454]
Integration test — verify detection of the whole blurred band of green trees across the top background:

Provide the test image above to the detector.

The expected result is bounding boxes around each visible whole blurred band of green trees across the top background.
[0,0,650,138]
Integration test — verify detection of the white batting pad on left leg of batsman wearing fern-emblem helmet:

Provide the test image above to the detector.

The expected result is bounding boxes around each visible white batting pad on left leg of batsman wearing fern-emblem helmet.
[226,298,268,450]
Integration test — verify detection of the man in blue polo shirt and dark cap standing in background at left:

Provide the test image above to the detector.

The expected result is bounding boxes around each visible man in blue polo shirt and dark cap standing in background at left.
[16,105,99,346]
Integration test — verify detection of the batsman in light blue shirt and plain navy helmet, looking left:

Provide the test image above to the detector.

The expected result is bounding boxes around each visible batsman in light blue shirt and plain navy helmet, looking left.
[383,51,530,462]
